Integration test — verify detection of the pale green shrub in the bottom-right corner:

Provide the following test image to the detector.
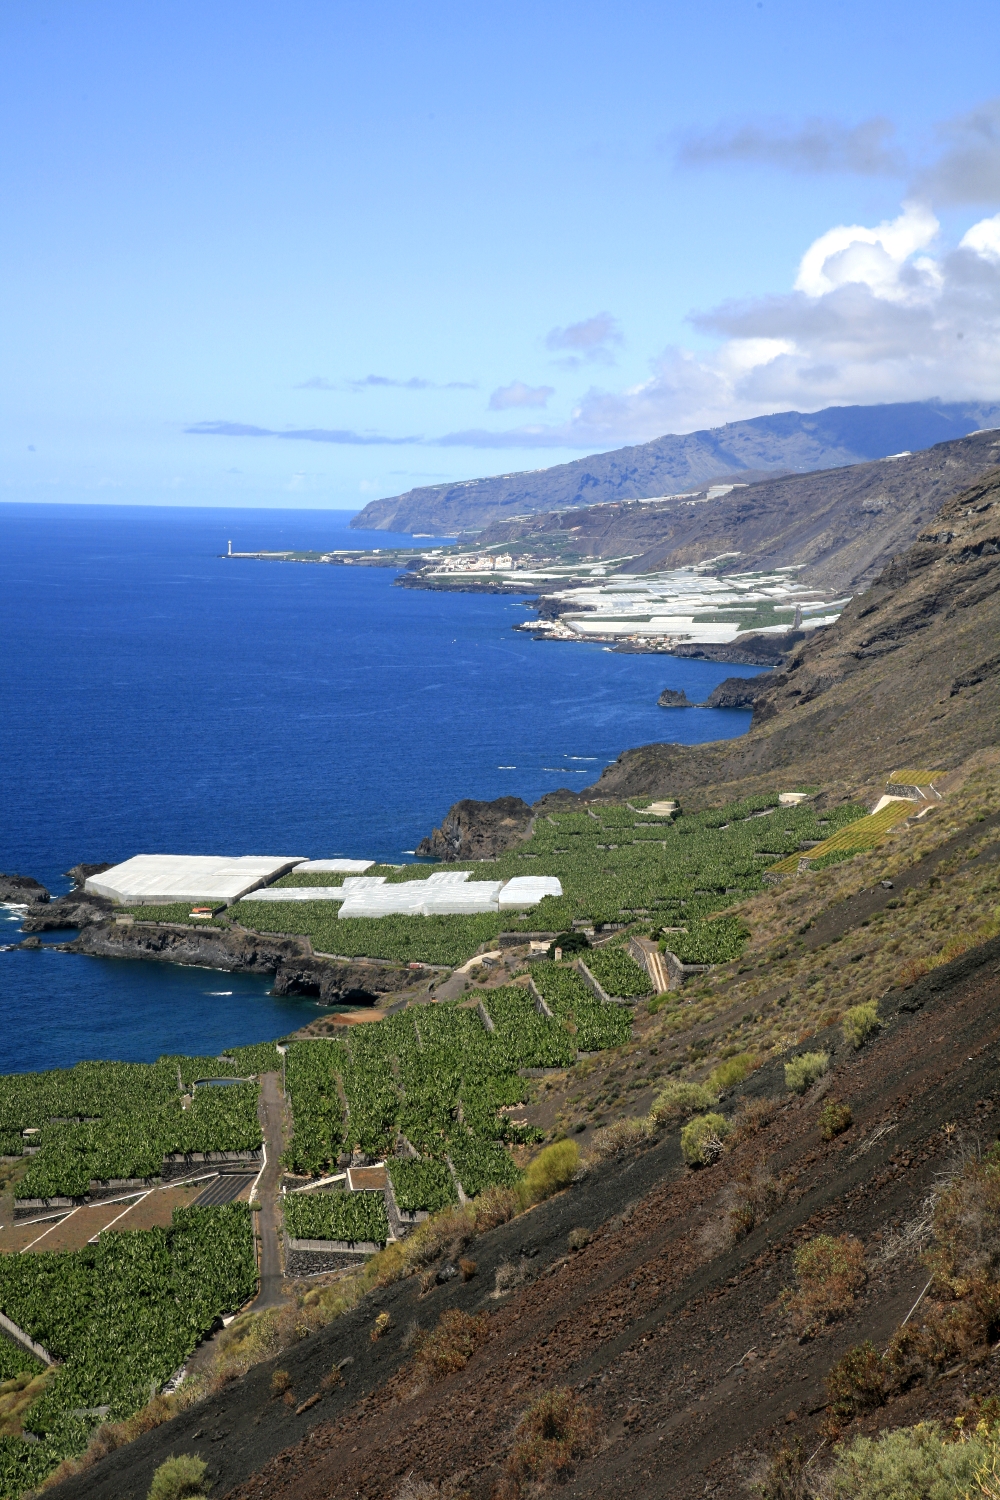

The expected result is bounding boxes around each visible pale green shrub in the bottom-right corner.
[826,1422,990,1500]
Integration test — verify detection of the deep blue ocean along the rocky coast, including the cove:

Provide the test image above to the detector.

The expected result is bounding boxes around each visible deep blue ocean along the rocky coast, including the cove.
[0,504,754,1073]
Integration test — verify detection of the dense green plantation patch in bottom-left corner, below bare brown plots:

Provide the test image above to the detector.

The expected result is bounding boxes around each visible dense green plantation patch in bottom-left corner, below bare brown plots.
[0,1203,256,1500]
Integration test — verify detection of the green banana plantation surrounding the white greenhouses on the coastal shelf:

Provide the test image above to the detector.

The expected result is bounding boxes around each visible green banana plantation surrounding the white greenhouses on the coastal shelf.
[228,792,865,965]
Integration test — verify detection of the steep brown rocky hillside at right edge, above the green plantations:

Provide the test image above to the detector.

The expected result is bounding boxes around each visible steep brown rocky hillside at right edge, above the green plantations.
[582,470,1000,800]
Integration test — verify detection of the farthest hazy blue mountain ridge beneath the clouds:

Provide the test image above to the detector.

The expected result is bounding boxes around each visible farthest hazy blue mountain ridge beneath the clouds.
[351,401,1000,537]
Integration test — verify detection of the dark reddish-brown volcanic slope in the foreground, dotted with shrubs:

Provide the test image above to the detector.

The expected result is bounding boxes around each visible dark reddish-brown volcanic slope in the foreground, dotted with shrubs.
[54,941,1000,1500]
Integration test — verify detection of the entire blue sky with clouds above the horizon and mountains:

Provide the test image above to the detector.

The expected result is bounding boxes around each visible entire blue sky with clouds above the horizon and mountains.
[0,0,1000,509]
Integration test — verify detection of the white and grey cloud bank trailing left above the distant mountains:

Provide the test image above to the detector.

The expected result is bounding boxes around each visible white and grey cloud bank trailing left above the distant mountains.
[187,201,1000,450]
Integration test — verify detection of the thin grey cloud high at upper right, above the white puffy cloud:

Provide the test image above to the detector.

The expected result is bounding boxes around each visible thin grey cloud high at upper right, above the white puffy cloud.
[675,116,906,177]
